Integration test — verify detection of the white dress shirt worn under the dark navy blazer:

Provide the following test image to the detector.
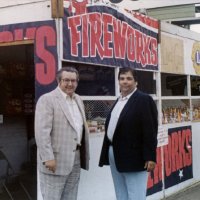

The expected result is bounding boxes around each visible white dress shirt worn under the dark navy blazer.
[107,89,136,142]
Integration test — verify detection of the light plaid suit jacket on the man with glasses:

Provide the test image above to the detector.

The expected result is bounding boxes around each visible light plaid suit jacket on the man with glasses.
[35,88,89,175]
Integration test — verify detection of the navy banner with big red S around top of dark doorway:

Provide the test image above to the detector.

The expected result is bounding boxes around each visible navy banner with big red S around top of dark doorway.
[0,21,58,101]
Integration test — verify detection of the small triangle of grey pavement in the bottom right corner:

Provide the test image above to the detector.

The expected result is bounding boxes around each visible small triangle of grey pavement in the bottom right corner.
[163,182,200,200]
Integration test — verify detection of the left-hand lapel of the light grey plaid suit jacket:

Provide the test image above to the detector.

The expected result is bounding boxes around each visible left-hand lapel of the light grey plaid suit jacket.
[55,89,76,130]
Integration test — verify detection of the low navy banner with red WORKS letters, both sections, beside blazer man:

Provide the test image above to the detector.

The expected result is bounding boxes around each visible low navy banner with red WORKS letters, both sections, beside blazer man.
[147,126,193,195]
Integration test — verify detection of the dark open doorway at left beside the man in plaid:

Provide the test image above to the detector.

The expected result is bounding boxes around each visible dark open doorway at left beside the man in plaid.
[0,43,37,200]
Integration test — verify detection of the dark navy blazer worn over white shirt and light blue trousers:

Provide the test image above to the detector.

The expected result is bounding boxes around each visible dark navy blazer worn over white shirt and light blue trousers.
[99,89,158,172]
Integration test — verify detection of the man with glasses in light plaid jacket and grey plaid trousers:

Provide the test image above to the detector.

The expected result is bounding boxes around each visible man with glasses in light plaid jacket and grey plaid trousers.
[35,67,89,200]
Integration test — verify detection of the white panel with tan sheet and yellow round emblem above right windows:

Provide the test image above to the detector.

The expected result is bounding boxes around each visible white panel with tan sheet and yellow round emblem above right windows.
[160,32,200,75]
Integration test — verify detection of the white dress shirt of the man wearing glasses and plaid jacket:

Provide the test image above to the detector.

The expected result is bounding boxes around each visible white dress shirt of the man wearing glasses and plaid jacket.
[58,87,83,145]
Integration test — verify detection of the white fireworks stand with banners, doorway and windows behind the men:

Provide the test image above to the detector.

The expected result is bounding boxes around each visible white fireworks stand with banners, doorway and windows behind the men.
[0,0,200,200]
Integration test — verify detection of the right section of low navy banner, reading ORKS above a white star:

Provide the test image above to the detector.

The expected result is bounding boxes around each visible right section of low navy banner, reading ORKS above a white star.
[164,126,193,188]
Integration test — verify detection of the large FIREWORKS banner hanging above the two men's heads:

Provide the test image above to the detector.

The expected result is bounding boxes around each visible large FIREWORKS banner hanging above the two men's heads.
[63,0,158,70]
